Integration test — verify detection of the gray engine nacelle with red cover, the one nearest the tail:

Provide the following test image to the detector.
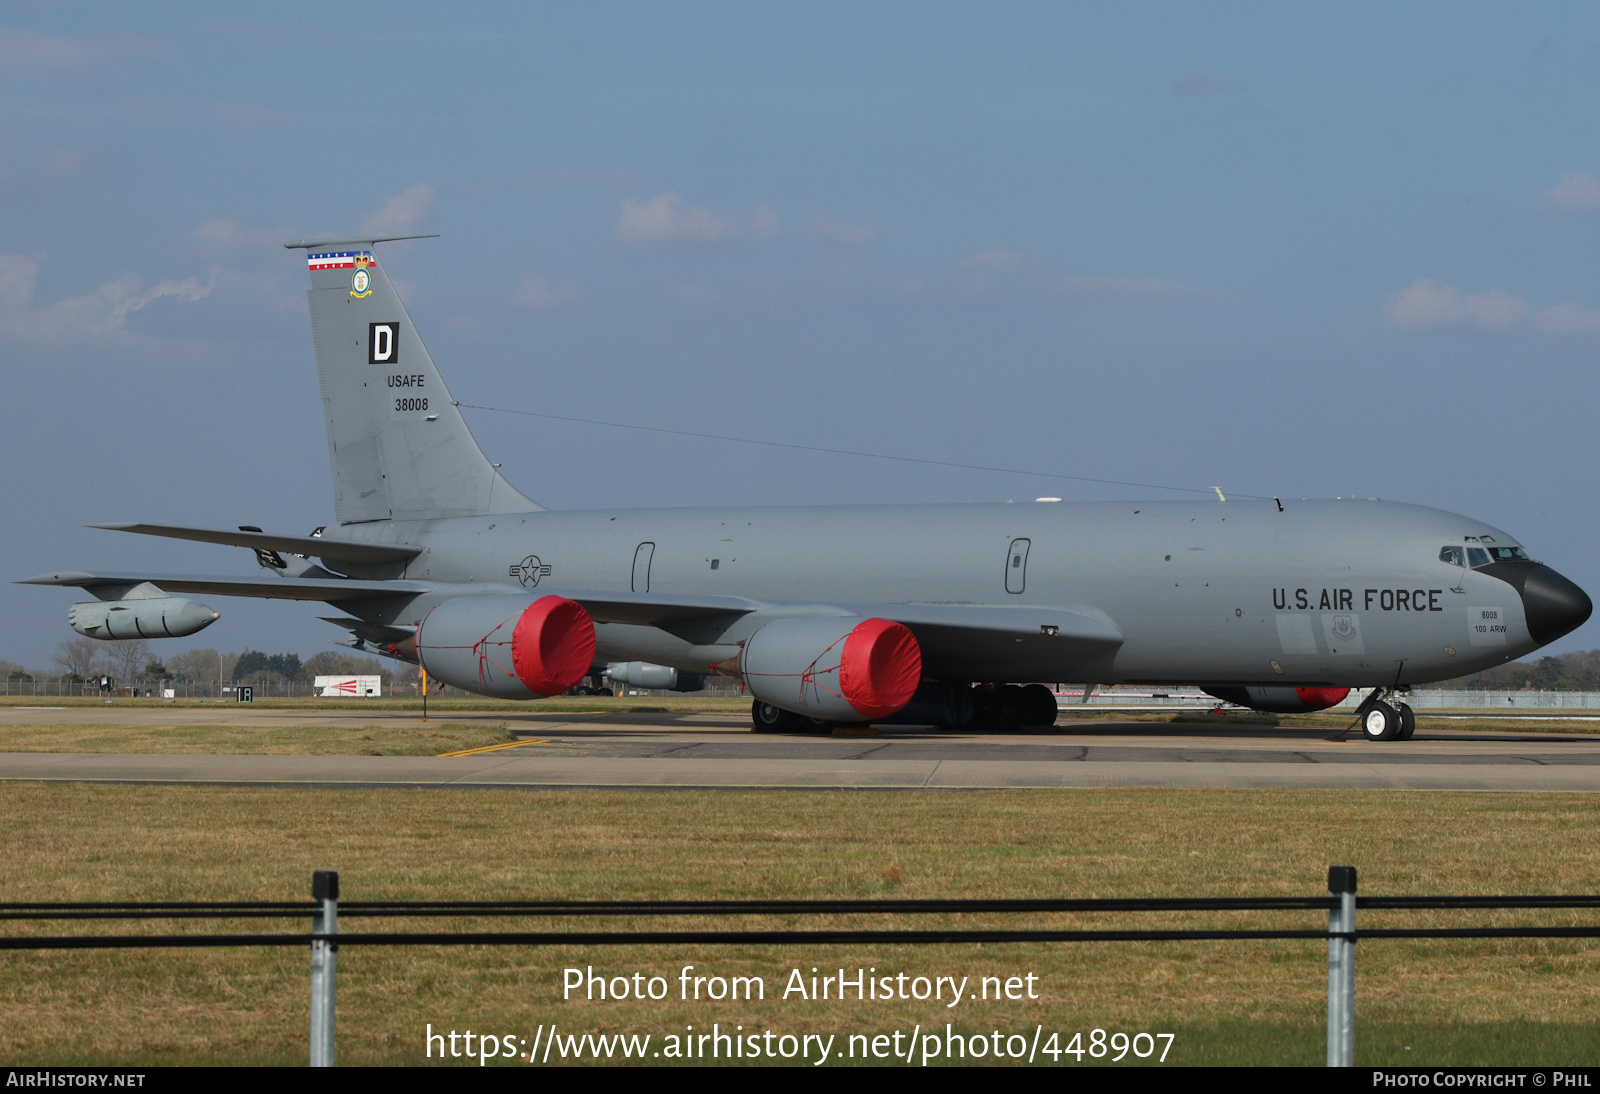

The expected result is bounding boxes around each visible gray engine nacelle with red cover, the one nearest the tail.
[416,595,595,699]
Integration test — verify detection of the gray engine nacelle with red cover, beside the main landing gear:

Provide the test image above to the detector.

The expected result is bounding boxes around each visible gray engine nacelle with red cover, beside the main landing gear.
[739,616,922,721]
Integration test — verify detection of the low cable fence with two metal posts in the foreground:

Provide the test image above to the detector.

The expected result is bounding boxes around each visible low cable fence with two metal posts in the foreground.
[0,865,1600,1067]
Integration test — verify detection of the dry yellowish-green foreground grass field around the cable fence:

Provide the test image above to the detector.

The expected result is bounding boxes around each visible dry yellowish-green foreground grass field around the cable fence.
[0,784,1600,1065]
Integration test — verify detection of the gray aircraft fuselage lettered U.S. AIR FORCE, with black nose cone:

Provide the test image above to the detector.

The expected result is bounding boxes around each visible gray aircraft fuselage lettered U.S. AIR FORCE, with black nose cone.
[339,501,1589,686]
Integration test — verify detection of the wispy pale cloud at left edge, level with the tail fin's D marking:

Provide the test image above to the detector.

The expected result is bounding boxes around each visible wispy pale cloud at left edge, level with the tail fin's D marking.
[0,254,216,345]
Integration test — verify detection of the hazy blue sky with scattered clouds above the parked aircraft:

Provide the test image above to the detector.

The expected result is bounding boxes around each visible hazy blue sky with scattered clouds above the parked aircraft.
[0,2,1600,667]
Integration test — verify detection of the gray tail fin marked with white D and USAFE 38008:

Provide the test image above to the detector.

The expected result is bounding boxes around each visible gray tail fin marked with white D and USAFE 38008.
[283,237,539,525]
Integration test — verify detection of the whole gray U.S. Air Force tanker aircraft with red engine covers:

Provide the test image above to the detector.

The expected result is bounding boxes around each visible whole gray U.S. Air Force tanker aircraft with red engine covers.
[27,237,1592,741]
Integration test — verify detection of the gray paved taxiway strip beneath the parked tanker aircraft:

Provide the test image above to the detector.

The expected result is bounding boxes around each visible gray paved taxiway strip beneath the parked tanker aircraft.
[0,707,1600,792]
